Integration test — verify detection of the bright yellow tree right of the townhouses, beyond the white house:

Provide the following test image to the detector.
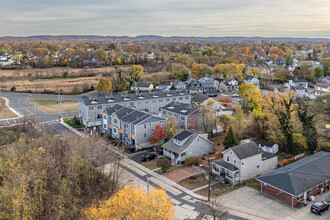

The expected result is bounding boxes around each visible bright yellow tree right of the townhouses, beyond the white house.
[238,83,261,111]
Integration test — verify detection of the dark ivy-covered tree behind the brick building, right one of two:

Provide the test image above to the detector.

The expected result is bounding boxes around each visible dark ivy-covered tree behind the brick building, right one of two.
[298,107,318,153]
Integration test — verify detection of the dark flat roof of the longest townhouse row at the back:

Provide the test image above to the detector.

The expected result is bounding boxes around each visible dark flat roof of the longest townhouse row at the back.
[79,90,189,106]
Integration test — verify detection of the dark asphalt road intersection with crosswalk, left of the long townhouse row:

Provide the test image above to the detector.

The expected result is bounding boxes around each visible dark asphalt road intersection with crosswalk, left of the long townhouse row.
[0,92,79,135]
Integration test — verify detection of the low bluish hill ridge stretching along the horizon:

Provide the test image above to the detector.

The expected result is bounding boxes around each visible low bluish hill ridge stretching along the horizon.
[0,35,330,42]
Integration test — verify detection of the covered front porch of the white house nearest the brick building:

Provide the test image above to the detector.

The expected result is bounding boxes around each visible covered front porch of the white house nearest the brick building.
[212,159,239,183]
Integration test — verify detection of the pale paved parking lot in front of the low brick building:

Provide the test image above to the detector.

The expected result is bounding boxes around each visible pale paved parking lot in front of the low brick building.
[220,186,330,220]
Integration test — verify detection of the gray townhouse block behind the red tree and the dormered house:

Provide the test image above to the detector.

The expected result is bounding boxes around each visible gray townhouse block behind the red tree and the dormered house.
[161,102,199,129]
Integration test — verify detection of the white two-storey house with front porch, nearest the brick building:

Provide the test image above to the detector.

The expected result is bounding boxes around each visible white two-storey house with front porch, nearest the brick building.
[212,141,277,182]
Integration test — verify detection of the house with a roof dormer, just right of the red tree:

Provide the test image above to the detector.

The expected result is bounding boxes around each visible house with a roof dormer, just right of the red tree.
[162,129,213,164]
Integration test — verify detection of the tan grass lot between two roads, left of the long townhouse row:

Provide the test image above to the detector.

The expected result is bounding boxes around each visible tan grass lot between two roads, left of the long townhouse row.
[29,98,78,113]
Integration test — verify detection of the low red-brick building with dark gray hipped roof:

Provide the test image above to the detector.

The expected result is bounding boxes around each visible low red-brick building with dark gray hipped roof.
[256,151,330,207]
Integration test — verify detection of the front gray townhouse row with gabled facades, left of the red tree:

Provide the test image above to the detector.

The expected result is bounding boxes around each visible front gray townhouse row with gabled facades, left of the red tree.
[102,104,166,150]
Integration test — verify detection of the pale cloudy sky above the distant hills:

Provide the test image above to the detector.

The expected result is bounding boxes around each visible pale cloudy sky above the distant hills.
[0,0,330,38]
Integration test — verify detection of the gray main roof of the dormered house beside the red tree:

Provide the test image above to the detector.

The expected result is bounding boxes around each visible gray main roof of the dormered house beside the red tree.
[162,129,212,154]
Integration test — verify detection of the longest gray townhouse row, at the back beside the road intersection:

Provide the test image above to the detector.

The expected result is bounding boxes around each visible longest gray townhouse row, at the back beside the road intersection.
[78,90,191,127]
